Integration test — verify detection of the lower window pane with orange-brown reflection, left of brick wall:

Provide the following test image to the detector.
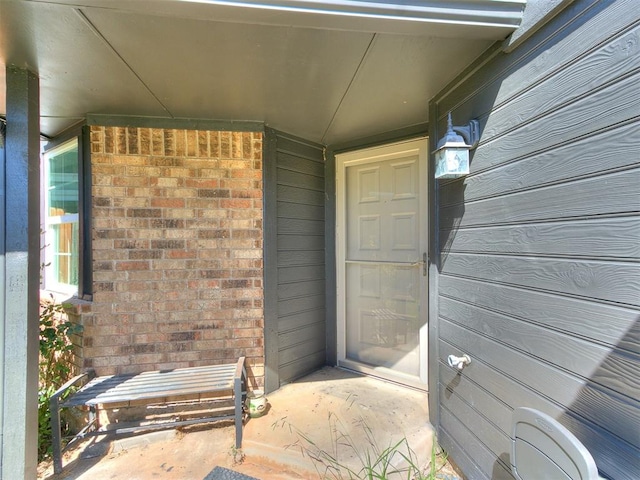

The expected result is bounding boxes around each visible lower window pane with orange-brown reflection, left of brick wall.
[51,222,79,286]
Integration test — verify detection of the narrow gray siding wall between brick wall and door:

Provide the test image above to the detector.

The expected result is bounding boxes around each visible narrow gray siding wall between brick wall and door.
[265,130,326,389]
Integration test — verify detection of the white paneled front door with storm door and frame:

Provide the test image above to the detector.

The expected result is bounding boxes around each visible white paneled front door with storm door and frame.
[336,139,428,389]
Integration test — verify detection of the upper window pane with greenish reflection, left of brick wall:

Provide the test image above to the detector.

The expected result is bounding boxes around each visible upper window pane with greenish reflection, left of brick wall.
[47,142,78,216]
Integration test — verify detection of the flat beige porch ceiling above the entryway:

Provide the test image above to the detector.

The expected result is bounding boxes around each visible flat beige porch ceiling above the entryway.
[0,0,524,144]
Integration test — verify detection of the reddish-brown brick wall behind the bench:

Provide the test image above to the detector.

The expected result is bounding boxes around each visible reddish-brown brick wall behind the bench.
[82,126,264,385]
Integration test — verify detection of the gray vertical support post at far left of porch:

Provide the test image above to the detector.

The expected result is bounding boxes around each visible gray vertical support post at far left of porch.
[0,66,40,479]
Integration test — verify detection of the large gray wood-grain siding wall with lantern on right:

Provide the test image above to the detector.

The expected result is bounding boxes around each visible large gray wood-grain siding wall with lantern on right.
[430,0,640,480]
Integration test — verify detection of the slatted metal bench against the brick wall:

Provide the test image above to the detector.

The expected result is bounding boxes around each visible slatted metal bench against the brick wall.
[49,357,247,473]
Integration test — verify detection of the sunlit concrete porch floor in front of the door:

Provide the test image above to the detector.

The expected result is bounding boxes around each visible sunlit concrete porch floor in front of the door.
[39,367,433,480]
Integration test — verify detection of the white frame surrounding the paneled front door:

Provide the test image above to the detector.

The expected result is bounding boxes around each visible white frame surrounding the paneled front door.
[335,135,430,391]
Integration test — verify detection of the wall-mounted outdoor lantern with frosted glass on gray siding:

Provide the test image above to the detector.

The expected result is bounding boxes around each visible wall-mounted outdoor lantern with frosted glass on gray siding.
[435,112,480,178]
